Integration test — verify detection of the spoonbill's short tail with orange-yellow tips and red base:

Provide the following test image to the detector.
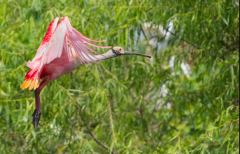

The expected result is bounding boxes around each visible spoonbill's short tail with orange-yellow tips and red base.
[21,69,40,90]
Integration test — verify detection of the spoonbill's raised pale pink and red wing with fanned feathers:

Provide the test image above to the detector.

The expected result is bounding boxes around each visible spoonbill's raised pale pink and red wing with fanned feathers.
[27,17,111,82]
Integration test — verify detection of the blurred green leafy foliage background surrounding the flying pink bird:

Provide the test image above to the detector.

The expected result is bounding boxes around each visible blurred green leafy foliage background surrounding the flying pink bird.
[0,0,239,154]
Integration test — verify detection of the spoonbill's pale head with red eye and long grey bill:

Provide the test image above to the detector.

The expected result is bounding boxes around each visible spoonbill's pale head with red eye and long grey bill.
[107,46,151,59]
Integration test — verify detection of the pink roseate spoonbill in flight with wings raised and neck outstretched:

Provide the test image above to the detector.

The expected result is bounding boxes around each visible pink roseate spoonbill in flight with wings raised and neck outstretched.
[21,17,151,129]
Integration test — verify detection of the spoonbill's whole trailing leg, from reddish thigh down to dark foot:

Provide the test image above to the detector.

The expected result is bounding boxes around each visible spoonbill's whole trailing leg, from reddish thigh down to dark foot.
[32,80,49,129]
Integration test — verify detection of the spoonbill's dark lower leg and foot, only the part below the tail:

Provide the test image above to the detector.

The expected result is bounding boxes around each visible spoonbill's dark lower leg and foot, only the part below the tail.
[32,89,41,129]
